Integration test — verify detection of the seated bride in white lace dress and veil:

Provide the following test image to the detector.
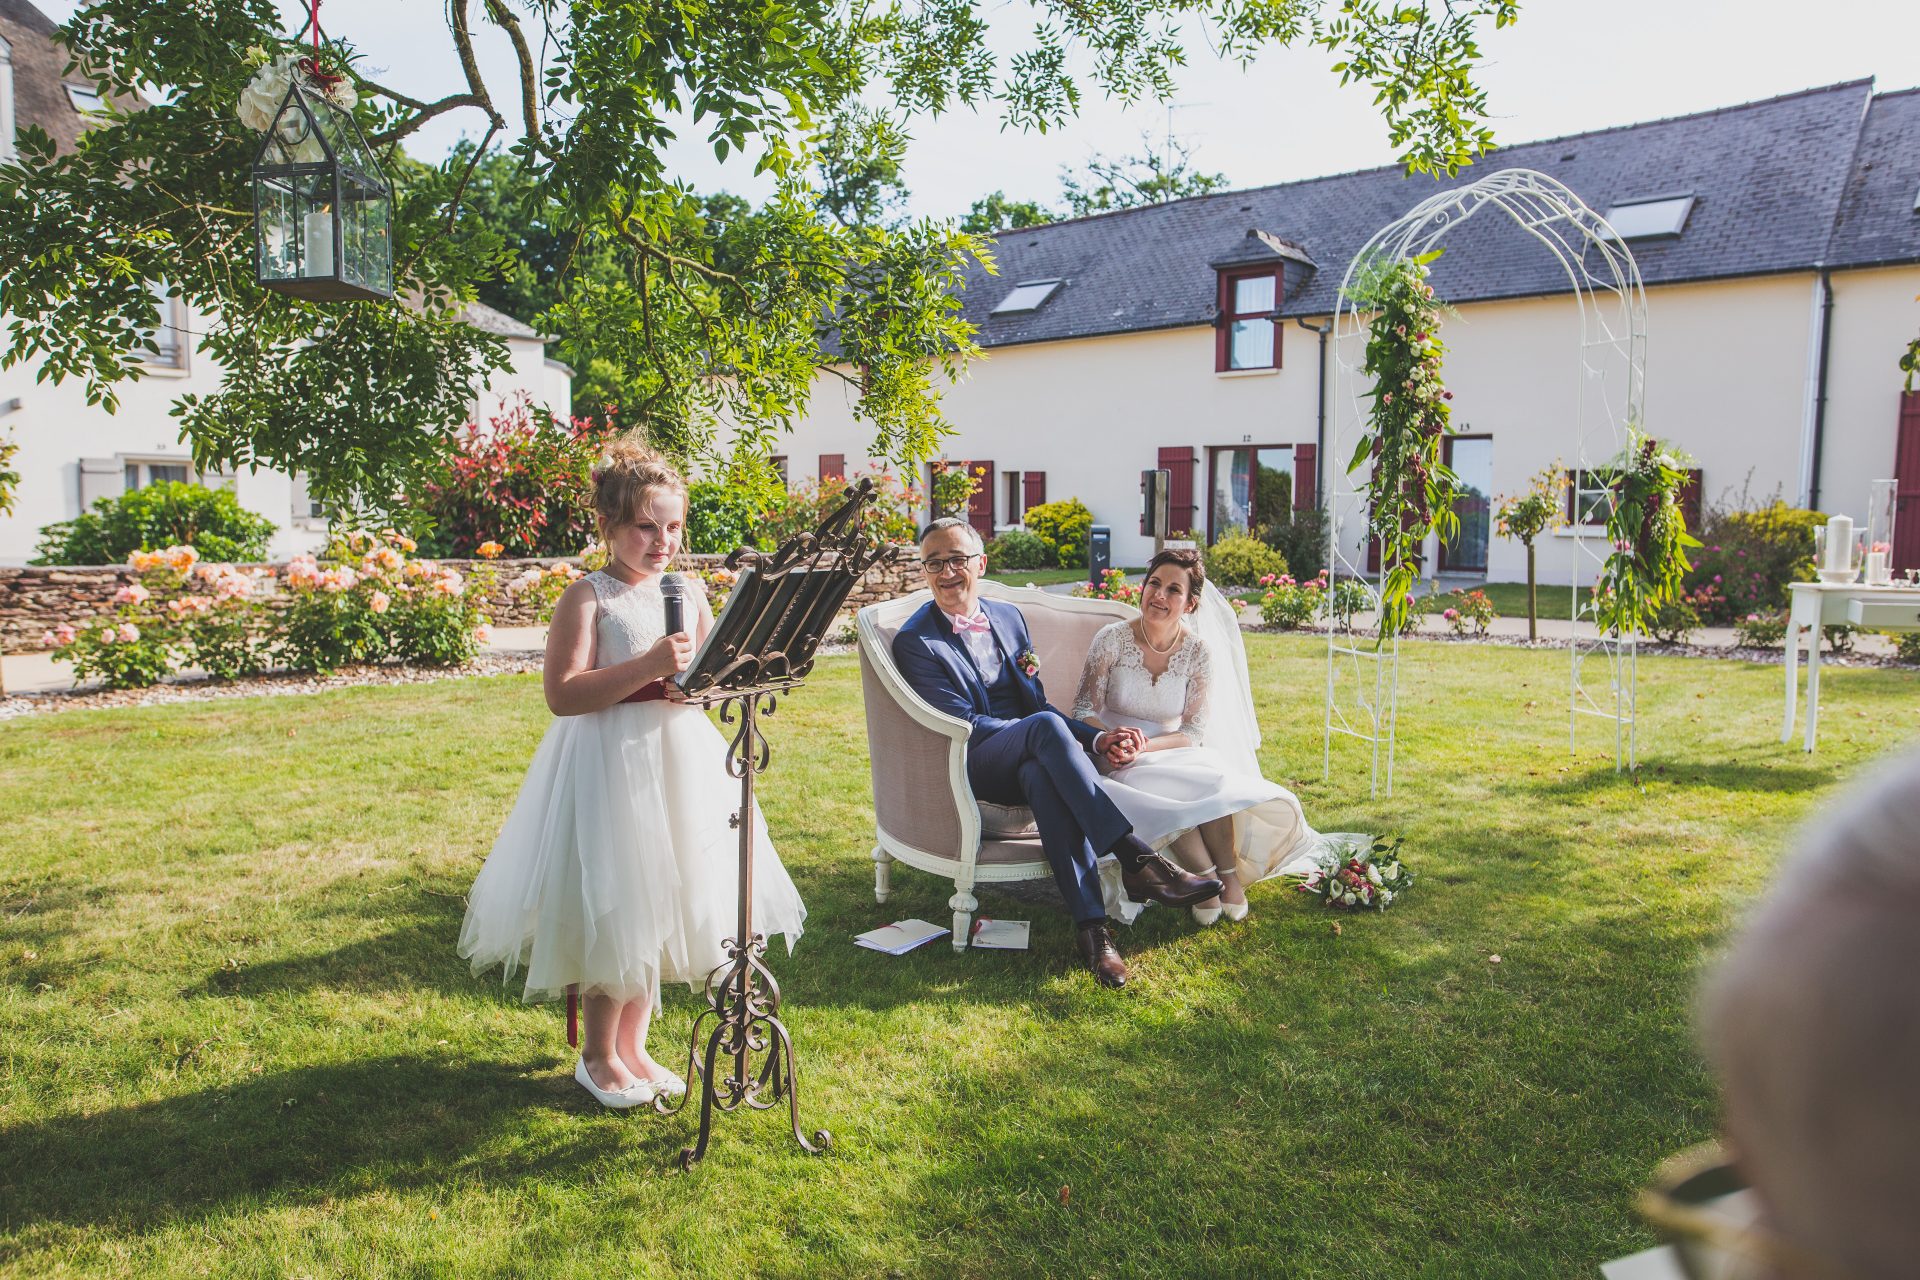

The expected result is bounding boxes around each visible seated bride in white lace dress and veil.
[1073,551,1332,925]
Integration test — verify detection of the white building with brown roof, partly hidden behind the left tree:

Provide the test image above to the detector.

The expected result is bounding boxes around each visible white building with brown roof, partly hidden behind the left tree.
[0,0,572,564]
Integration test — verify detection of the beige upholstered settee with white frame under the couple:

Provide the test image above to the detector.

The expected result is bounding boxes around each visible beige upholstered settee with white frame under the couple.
[858,581,1139,950]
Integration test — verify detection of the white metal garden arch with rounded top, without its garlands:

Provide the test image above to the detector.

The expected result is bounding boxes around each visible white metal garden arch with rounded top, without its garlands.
[1321,169,1647,794]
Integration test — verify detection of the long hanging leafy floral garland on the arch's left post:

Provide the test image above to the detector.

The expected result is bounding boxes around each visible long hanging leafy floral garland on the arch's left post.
[1346,249,1459,641]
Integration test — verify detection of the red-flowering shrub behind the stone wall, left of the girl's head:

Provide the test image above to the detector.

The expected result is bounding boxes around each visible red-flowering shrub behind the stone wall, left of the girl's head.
[411,397,614,557]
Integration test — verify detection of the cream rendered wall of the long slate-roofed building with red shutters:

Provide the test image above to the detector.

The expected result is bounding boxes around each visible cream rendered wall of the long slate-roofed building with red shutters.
[756,273,1850,585]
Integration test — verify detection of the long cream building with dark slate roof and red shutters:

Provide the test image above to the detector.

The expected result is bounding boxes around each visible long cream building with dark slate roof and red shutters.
[783,81,1920,583]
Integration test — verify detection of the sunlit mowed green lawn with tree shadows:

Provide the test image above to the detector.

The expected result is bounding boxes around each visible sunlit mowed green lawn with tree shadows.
[0,635,1920,1280]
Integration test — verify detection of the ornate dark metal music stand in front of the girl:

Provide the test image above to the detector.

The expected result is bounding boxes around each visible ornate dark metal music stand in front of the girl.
[653,480,891,1169]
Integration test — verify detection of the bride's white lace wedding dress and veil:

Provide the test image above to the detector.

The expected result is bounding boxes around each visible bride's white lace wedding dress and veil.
[1073,585,1365,898]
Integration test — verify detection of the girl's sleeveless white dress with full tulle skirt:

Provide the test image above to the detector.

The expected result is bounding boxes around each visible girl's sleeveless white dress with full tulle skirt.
[459,572,806,1000]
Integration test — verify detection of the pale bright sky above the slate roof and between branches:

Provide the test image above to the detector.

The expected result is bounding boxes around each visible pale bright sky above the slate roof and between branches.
[36,0,1920,217]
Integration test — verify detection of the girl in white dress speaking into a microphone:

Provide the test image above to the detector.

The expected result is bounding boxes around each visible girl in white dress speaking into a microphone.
[461,441,806,1107]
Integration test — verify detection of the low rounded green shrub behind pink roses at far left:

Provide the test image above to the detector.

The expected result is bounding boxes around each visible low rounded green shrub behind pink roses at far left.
[33,480,275,564]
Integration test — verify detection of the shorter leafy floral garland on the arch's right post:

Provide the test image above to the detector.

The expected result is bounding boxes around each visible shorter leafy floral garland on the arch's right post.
[1594,424,1699,635]
